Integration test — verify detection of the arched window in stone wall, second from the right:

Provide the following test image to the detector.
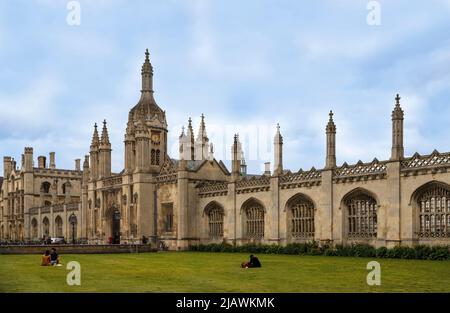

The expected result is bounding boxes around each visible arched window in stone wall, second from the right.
[345,192,378,239]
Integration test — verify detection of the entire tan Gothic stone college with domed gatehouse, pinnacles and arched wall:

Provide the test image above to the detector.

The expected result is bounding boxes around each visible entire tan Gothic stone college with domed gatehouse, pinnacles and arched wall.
[1,52,450,249]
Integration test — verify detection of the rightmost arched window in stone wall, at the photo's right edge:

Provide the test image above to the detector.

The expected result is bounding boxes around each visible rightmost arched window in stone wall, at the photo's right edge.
[417,184,450,238]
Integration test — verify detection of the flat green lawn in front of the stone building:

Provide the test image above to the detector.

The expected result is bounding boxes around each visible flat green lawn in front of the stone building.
[0,252,450,292]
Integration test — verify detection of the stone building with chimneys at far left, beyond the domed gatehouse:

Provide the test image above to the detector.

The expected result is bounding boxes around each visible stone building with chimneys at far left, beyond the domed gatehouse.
[0,151,82,241]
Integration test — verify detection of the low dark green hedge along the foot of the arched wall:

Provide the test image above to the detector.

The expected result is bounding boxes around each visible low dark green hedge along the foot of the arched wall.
[189,242,450,260]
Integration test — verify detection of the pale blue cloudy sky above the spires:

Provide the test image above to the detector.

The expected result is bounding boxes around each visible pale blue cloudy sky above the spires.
[0,0,450,173]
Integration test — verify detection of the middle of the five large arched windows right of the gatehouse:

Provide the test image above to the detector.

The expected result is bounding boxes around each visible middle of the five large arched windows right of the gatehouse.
[288,195,314,238]
